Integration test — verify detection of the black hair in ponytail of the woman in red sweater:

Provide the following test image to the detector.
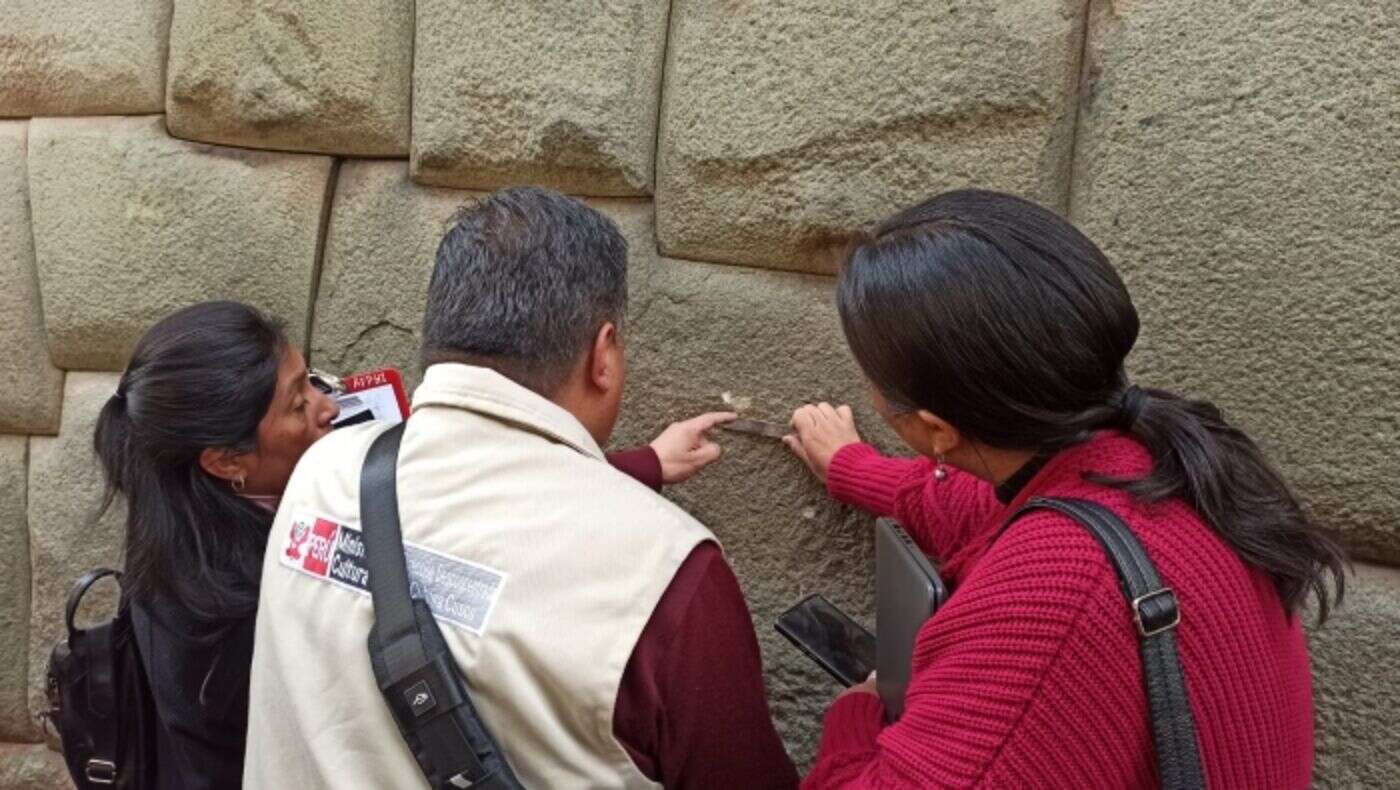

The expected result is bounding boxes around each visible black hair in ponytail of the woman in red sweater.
[837,189,1347,621]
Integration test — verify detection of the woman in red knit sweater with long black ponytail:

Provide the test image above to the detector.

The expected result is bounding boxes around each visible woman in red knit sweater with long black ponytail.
[787,190,1345,787]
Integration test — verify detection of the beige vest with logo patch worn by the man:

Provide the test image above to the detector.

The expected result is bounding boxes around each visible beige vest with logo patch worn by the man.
[244,364,714,790]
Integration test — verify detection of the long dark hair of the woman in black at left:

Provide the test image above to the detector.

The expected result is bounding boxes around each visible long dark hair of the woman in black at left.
[92,301,287,622]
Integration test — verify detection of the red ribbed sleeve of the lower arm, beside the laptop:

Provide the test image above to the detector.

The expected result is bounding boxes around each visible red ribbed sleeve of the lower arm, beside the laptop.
[804,514,1147,789]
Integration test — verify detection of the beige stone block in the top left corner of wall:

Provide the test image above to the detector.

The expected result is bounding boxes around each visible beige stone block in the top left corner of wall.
[0,0,171,118]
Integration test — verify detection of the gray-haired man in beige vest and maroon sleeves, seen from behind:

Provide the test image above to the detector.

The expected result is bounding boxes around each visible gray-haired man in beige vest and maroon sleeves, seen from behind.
[245,189,797,790]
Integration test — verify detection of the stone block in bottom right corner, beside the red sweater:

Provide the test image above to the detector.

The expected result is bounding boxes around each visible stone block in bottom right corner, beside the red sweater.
[1309,564,1400,789]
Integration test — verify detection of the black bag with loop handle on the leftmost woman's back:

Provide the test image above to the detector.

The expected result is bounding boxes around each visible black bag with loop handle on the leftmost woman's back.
[43,567,157,790]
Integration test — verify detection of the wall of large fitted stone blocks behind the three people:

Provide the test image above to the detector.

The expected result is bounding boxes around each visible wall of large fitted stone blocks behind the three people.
[0,0,1400,787]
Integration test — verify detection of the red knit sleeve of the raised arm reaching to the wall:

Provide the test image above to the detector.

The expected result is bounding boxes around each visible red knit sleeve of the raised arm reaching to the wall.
[826,443,1001,559]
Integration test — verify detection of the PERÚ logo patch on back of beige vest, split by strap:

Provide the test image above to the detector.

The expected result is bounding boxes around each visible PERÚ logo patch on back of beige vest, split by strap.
[277,513,505,636]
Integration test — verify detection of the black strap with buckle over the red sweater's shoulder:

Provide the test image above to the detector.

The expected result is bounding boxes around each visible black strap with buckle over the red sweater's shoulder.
[1002,497,1205,790]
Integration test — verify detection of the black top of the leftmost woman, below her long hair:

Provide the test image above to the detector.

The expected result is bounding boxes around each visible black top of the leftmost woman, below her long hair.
[132,598,253,790]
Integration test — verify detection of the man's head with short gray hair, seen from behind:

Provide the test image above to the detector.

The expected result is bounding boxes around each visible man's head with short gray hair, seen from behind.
[423,186,627,398]
